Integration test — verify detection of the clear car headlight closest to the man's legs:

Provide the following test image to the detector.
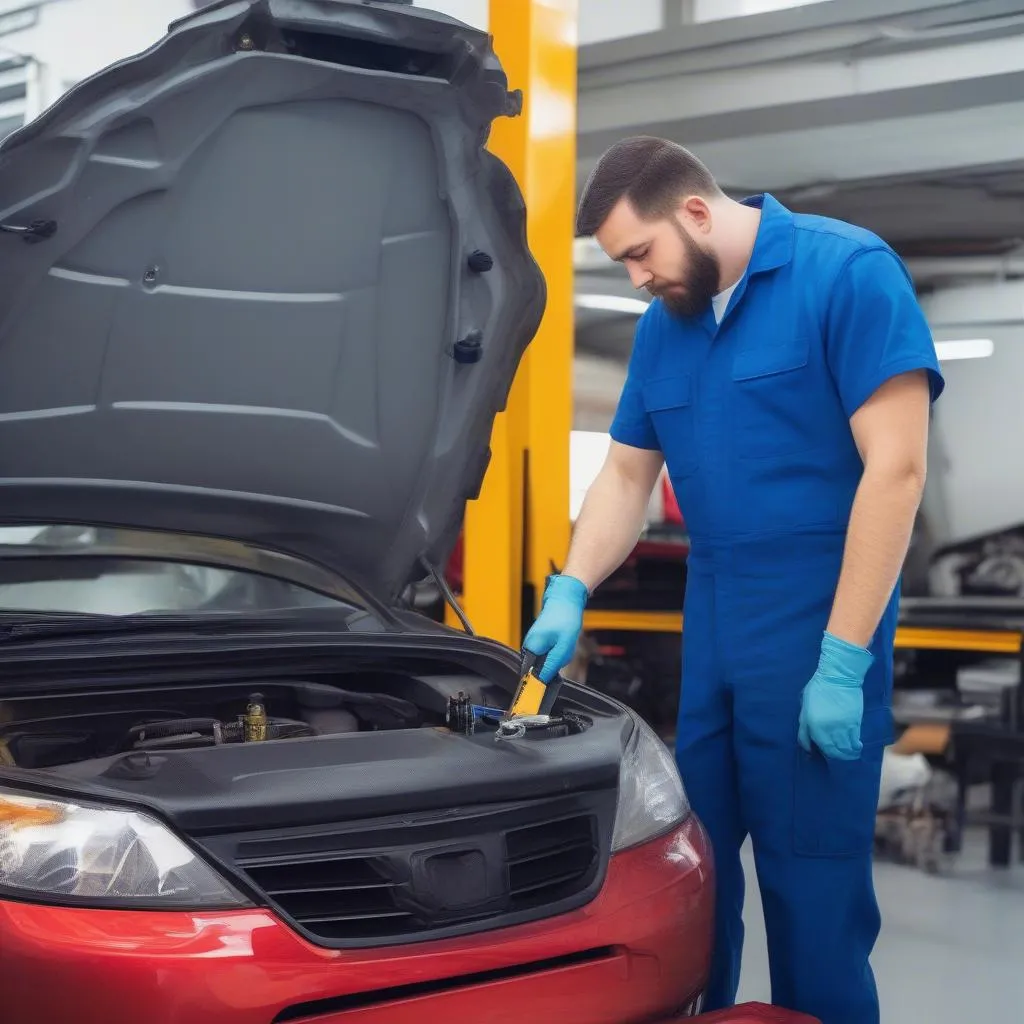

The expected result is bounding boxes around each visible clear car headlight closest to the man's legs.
[611,712,690,853]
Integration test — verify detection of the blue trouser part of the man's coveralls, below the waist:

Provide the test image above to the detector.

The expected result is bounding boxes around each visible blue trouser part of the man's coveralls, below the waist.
[676,542,895,1024]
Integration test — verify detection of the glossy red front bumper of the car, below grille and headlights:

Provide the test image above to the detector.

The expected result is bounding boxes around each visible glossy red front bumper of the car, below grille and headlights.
[0,819,714,1024]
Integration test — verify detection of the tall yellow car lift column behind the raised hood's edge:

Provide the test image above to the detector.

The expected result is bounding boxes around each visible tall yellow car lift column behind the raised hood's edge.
[463,0,579,647]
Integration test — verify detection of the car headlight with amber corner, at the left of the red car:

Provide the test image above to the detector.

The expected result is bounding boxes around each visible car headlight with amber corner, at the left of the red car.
[0,790,247,909]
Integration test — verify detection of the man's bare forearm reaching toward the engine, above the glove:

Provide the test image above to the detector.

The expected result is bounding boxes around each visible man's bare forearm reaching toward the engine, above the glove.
[563,470,650,592]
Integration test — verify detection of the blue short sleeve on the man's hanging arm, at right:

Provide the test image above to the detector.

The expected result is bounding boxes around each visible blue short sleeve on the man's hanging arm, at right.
[826,248,945,417]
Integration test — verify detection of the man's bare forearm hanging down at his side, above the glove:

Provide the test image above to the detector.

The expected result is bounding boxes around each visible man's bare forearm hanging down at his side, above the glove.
[827,467,924,647]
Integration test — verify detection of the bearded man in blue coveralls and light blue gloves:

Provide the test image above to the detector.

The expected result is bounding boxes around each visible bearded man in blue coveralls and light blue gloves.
[524,137,943,1024]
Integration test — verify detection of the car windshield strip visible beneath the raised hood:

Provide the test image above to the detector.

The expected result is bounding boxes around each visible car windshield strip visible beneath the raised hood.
[0,525,370,615]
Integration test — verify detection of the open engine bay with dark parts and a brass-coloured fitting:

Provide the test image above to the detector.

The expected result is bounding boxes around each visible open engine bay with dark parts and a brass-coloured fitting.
[0,672,587,769]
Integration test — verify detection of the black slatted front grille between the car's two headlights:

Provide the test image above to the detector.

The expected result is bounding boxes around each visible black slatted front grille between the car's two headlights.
[204,791,615,947]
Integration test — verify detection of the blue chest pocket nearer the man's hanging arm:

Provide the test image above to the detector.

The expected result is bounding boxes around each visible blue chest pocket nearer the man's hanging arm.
[732,335,821,459]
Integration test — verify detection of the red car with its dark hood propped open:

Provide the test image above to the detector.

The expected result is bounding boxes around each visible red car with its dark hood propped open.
[0,0,815,1024]
